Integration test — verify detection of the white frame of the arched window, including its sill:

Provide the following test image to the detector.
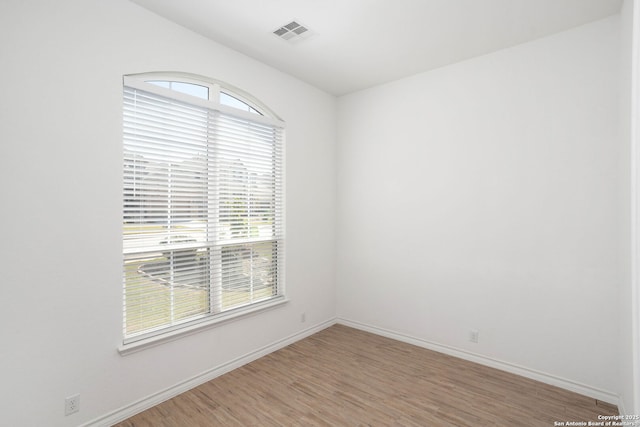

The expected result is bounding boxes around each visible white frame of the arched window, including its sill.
[119,72,288,355]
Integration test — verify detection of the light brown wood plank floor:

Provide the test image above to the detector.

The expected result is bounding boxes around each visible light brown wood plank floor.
[117,325,618,427]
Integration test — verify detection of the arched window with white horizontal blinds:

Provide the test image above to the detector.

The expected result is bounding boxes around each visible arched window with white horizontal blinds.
[123,74,284,345]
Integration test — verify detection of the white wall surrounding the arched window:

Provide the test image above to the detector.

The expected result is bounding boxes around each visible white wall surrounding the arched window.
[0,0,335,426]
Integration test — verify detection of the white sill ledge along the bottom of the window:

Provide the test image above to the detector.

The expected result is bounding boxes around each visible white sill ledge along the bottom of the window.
[118,297,289,356]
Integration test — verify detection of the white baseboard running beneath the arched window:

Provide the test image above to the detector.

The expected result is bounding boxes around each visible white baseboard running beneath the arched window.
[81,319,336,427]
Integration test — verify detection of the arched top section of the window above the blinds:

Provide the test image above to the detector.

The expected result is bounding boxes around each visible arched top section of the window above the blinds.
[125,72,280,121]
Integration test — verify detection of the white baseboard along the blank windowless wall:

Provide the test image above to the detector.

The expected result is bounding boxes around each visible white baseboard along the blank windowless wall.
[337,318,623,413]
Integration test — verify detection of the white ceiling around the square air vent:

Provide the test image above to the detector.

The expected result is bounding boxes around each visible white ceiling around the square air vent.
[132,0,622,95]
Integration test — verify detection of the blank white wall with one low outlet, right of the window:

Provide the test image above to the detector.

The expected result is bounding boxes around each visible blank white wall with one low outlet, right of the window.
[337,16,628,400]
